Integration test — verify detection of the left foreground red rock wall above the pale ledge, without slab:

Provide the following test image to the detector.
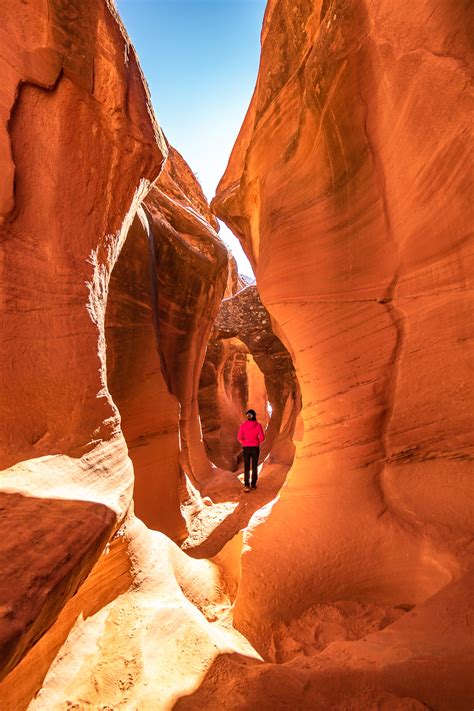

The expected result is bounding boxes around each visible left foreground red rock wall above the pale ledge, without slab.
[0,0,166,467]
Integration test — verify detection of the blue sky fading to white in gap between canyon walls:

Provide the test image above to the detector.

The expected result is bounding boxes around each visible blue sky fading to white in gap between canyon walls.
[116,0,266,274]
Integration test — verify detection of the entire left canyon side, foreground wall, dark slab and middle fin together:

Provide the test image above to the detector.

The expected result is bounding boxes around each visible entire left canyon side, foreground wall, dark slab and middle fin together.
[0,0,228,676]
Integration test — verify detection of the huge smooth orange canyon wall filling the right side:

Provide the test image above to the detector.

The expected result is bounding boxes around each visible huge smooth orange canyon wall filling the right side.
[213,0,473,705]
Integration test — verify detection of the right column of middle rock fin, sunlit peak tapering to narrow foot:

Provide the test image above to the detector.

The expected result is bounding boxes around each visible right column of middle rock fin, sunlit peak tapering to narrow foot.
[145,148,228,487]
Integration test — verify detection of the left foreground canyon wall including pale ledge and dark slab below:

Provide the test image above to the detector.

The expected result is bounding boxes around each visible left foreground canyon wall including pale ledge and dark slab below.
[0,0,167,674]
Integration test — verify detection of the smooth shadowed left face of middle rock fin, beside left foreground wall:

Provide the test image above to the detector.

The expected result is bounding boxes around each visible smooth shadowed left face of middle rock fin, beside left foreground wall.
[105,208,186,539]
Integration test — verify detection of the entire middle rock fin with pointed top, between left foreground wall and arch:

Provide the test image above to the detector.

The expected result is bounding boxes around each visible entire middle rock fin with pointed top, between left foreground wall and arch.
[106,147,228,539]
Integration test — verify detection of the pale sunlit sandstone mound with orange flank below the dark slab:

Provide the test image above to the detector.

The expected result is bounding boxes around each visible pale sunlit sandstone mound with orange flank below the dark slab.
[0,517,259,710]
